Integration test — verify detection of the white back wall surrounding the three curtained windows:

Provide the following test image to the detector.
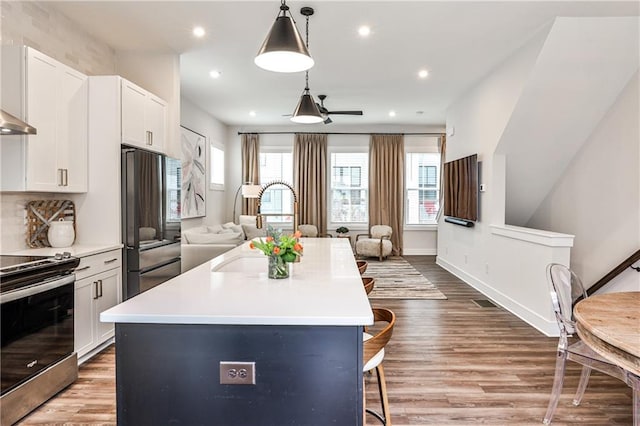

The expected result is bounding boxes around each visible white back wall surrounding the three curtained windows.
[225,123,444,255]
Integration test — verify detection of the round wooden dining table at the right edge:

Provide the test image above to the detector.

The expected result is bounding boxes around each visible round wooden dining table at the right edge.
[573,291,640,376]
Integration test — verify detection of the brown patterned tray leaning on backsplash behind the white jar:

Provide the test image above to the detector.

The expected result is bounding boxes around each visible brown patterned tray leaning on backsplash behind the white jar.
[26,200,77,248]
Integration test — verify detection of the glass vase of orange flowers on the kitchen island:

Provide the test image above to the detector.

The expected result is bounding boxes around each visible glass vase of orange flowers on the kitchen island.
[249,229,302,279]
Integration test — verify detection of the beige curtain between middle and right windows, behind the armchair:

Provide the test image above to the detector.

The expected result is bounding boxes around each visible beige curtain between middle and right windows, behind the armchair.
[369,135,404,256]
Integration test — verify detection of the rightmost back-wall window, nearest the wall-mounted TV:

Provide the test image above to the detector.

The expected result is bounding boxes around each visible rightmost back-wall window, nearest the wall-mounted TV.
[405,152,440,225]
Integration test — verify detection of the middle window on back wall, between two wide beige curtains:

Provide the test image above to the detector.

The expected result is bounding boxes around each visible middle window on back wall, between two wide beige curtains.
[329,152,369,226]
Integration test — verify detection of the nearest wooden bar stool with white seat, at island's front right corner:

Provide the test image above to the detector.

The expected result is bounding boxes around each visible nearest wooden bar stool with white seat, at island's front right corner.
[362,308,396,426]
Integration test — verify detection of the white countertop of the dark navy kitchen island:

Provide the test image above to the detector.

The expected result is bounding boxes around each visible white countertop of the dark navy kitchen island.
[100,238,373,326]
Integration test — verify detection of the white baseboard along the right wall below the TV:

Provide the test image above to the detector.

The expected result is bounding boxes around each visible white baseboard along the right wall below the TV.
[436,256,560,337]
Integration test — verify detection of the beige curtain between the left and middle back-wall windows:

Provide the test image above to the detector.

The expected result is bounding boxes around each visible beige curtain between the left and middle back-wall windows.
[293,134,327,234]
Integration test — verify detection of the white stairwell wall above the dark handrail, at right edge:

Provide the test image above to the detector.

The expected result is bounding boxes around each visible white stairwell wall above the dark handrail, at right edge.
[527,74,640,290]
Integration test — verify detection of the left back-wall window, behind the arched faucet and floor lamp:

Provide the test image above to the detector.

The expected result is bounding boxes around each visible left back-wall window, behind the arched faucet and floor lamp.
[260,152,293,226]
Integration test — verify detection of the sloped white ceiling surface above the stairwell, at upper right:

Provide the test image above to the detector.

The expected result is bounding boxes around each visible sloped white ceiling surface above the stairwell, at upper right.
[496,18,639,226]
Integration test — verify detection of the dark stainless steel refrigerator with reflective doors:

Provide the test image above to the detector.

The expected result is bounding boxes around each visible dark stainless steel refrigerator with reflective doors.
[121,145,181,299]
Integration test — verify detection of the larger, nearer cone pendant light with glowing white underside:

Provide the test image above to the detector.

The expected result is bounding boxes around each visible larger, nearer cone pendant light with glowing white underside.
[253,0,314,72]
